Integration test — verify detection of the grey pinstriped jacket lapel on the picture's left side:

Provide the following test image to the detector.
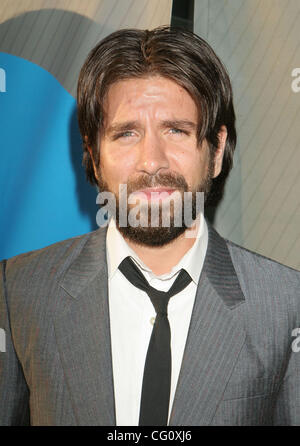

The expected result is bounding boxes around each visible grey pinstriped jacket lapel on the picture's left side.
[54,229,115,426]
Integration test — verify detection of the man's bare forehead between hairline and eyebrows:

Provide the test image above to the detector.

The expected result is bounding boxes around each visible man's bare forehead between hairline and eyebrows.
[104,76,197,122]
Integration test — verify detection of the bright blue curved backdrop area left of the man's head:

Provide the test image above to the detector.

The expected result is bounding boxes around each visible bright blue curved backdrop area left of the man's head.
[0,52,97,259]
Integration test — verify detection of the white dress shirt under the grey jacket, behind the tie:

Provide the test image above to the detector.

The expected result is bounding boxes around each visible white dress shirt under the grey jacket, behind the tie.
[106,214,208,426]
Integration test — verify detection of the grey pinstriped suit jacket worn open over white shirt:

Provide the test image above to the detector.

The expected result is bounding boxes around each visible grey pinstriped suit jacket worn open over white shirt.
[0,227,300,426]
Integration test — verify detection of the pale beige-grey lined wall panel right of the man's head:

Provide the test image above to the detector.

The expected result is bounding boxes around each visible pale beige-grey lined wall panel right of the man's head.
[194,0,300,269]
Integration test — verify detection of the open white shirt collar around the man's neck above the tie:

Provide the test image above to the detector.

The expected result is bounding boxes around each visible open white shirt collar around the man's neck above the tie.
[106,213,208,284]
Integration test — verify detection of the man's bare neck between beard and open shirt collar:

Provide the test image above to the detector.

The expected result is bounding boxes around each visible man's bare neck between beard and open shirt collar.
[126,219,199,276]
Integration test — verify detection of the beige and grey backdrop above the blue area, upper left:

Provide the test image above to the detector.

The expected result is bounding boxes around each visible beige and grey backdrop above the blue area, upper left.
[0,0,172,96]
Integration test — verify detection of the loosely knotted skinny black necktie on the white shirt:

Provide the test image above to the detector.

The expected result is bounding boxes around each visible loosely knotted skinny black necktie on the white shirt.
[119,257,192,426]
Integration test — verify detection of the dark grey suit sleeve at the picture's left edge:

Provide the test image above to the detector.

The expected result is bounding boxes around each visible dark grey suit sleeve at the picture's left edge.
[0,260,30,426]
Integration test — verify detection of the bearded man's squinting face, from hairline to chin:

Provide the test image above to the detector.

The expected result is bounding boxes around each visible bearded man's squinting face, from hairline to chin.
[96,76,222,246]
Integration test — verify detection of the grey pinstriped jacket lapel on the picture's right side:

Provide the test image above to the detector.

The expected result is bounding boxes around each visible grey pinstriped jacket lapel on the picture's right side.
[170,226,245,426]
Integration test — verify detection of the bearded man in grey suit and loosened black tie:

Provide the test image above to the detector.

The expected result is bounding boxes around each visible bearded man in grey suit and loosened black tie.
[0,27,300,426]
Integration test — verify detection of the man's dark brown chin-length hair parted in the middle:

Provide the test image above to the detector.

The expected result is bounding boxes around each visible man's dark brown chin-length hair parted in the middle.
[77,26,236,203]
